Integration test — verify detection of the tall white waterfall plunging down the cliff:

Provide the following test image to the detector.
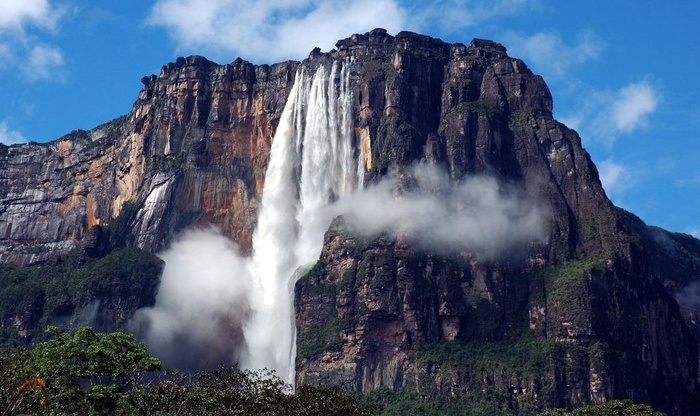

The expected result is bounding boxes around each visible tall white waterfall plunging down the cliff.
[242,60,364,384]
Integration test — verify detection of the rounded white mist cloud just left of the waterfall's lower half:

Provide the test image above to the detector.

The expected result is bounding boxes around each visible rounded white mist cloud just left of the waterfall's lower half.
[133,228,250,369]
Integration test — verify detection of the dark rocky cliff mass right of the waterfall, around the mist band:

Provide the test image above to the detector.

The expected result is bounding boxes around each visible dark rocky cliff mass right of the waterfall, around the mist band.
[296,31,698,414]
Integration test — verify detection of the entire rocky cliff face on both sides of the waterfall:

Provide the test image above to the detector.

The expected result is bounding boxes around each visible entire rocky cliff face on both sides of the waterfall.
[0,29,700,414]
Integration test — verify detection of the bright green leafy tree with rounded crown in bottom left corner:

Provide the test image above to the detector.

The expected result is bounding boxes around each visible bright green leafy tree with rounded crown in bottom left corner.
[2,326,161,415]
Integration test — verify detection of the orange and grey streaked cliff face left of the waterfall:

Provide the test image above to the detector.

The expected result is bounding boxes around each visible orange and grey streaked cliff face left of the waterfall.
[0,56,297,264]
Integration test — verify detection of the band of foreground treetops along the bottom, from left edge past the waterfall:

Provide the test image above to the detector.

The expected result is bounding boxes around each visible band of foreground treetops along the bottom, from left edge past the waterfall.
[0,327,376,416]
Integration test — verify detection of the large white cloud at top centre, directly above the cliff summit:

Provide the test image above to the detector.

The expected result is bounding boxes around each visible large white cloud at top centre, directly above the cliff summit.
[146,0,540,62]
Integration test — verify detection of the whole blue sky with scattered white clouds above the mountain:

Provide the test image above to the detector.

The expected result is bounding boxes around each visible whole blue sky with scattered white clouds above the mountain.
[0,0,700,237]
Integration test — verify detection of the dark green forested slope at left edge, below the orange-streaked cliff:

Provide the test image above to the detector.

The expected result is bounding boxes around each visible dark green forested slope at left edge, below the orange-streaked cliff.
[0,248,163,346]
